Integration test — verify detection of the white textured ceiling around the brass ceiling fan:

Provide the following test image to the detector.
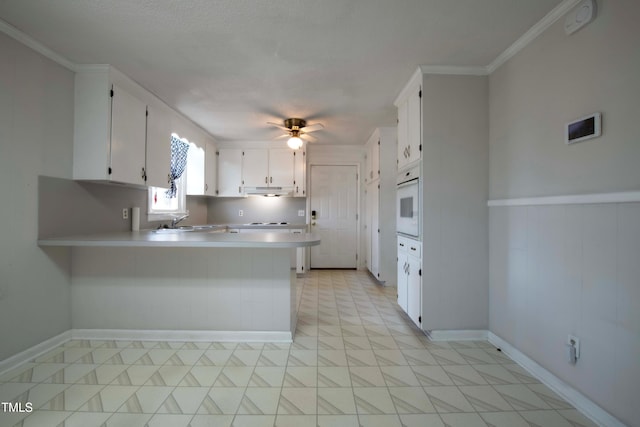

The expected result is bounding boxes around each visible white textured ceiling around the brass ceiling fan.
[0,0,561,144]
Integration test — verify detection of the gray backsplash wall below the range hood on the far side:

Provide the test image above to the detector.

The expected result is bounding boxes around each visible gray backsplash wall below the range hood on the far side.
[207,196,307,224]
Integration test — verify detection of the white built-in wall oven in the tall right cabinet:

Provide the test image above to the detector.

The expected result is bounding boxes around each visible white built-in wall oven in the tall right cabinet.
[396,168,420,238]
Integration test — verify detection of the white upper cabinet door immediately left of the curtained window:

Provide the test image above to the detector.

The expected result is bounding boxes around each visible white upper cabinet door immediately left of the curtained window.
[145,106,171,188]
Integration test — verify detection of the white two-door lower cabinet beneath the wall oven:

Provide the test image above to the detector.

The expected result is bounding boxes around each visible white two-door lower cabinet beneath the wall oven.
[398,237,422,326]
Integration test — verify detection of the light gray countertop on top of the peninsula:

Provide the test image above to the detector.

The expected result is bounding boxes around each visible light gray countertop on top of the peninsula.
[38,226,320,248]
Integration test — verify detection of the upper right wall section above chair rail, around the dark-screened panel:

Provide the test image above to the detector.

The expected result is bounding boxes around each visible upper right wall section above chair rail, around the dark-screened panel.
[490,1,640,199]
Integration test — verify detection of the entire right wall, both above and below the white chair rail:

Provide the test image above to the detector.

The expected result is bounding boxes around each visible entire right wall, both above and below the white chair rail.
[490,0,640,426]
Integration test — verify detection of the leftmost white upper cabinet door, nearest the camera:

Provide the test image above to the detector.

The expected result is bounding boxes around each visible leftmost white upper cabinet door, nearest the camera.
[110,85,147,185]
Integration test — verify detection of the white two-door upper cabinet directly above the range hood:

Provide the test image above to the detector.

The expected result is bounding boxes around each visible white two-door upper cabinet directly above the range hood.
[242,148,294,188]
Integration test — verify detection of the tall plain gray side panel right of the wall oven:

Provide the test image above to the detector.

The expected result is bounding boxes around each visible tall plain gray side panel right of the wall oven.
[422,76,489,330]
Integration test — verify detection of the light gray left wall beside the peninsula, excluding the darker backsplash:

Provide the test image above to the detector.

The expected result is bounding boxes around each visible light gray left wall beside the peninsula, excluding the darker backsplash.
[0,34,73,360]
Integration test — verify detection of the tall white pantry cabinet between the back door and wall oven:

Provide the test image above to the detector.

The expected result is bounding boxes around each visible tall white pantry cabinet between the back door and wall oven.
[364,127,396,285]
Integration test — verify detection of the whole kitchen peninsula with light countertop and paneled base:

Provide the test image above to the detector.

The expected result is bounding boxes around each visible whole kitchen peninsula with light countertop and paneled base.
[38,230,320,341]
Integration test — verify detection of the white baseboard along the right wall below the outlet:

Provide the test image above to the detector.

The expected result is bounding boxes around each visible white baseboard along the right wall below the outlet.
[488,332,625,427]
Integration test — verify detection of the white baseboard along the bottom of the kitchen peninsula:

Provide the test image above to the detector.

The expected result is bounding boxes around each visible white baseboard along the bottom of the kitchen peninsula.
[70,329,293,342]
